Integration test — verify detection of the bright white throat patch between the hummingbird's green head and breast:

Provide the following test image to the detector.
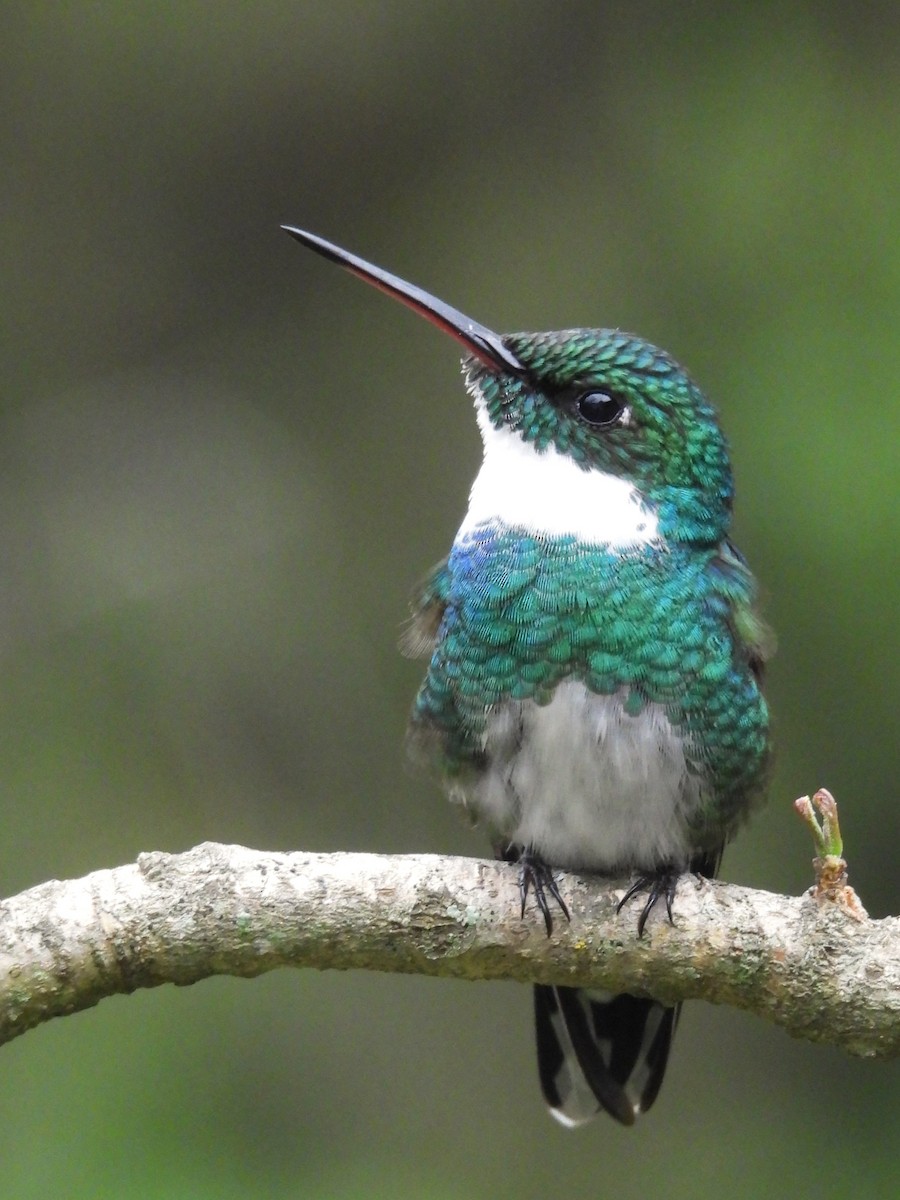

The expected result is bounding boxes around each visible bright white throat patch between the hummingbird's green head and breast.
[457,389,659,550]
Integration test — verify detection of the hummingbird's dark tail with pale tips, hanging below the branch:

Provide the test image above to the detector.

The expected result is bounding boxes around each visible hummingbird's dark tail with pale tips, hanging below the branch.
[534,984,680,1126]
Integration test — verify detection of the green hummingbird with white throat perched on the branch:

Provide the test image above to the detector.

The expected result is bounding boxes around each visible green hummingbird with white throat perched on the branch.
[282,226,773,1127]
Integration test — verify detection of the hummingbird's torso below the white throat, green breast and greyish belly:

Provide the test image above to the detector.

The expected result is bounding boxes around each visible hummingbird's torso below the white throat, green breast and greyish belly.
[412,526,768,854]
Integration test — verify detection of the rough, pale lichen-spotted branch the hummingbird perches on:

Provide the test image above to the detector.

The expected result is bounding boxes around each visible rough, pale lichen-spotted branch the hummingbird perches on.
[0,842,900,1057]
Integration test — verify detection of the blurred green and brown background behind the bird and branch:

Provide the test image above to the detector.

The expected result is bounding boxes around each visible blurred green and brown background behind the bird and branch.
[0,7,900,1200]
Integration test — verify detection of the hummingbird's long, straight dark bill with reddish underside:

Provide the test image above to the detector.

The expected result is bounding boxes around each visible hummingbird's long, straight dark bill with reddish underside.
[281,226,526,376]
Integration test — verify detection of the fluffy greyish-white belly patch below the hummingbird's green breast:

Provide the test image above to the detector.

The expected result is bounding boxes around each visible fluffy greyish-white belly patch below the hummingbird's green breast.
[456,680,703,874]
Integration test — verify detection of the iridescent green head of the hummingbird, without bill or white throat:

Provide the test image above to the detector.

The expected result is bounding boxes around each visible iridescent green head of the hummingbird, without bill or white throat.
[463,329,733,542]
